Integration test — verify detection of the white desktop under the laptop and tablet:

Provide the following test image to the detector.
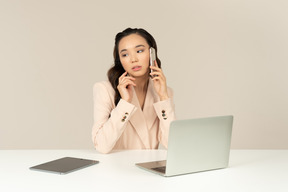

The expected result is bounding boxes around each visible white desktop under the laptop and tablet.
[0,150,288,192]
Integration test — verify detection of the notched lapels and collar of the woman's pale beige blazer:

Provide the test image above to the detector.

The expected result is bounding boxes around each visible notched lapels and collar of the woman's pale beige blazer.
[129,78,159,149]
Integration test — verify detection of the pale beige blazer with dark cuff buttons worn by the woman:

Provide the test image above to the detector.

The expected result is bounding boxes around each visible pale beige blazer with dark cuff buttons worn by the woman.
[92,80,175,153]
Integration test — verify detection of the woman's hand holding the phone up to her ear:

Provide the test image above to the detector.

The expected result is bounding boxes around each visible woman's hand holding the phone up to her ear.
[150,60,169,101]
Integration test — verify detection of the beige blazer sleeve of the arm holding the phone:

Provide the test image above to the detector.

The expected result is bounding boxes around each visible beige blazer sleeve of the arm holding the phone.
[154,88,176,148]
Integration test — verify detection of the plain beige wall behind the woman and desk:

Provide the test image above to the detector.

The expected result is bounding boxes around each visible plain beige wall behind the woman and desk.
[0,0,288,149]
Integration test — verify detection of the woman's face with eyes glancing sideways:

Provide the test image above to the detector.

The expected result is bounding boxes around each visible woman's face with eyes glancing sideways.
[118,34,150,77]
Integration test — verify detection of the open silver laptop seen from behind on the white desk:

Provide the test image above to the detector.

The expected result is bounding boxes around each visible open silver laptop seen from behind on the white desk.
[136,116,233,176]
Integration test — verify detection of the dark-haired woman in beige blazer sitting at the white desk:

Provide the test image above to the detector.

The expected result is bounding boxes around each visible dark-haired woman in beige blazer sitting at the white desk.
[92,28,175,153]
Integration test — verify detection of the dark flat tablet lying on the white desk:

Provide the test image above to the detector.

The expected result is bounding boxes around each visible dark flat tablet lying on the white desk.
[30,157,99,174]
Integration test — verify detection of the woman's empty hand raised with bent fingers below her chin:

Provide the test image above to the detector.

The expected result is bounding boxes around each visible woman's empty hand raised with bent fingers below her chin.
[117,71,136,103]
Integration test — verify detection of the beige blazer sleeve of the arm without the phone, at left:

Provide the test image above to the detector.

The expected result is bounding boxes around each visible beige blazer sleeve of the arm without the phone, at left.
[92,82,136,153]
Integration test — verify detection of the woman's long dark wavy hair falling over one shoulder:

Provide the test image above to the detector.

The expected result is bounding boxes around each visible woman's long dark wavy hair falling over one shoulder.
[107,28,161,106]
